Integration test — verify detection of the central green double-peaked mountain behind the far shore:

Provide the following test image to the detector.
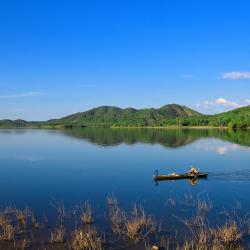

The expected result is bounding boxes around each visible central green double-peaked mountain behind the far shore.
[48,104,201,126]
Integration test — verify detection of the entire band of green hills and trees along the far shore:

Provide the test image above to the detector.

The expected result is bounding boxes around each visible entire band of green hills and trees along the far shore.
[0,104,250,129]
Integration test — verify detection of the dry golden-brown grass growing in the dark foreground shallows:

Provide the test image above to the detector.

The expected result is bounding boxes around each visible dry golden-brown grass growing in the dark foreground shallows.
[0,196,250,250]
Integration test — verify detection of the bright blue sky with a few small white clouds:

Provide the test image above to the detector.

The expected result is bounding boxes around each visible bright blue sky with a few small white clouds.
[0,0,250,120]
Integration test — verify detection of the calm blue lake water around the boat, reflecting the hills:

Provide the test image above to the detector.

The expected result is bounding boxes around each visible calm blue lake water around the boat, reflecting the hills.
[0,128,250,249]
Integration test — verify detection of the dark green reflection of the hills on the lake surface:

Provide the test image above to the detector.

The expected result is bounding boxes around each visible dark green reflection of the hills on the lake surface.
[63,128,250,148]
